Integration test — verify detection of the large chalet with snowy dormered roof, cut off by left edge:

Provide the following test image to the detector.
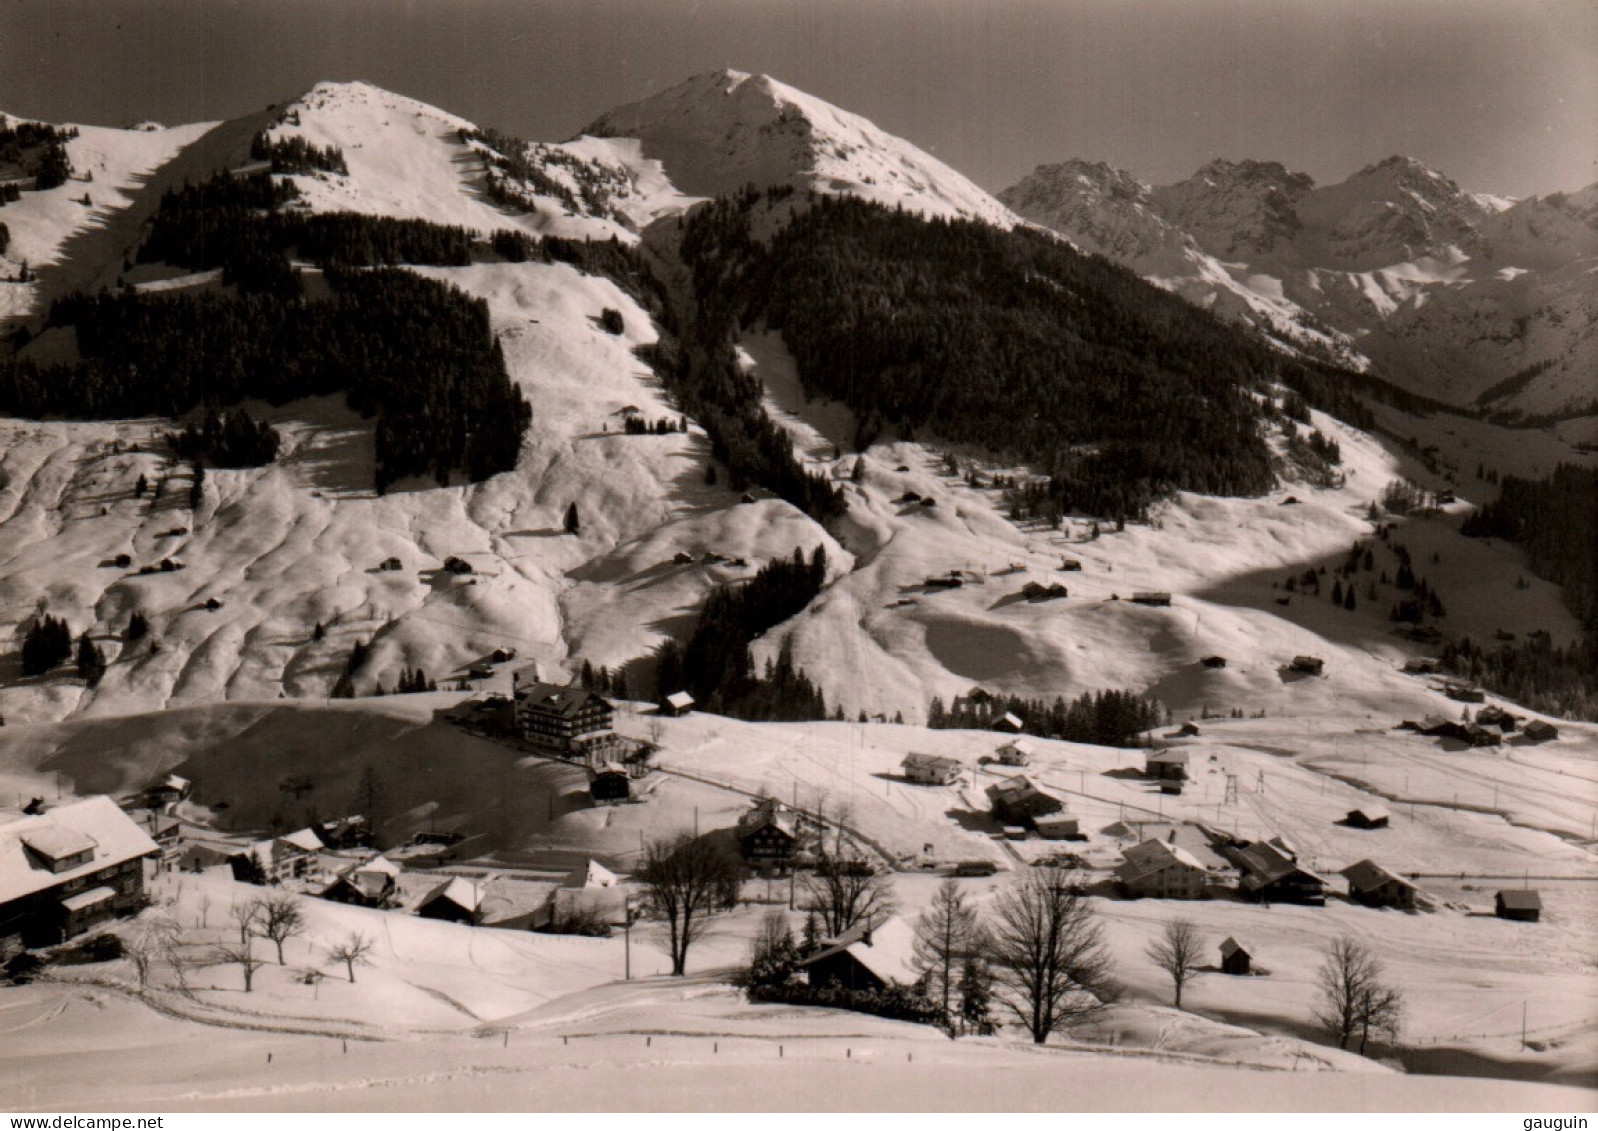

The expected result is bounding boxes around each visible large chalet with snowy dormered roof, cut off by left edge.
[0,797,160,944]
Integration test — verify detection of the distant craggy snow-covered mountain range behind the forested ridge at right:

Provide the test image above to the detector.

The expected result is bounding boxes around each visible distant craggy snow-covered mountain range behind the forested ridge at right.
[1000,157,1598,415]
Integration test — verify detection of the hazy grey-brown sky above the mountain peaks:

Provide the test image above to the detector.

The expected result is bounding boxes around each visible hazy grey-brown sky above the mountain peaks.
[0,0,1598,195]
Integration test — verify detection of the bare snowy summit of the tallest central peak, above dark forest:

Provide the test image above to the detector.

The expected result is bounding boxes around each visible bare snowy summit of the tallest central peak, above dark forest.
[583,70,1015,227]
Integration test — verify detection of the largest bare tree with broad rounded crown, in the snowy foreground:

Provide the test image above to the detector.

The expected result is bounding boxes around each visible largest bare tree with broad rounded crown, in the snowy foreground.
[988,867,1119,1045]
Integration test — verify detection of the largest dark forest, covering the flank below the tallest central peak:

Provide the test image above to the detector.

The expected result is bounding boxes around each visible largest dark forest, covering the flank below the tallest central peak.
[684,190,1380,518]
